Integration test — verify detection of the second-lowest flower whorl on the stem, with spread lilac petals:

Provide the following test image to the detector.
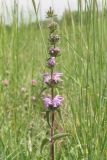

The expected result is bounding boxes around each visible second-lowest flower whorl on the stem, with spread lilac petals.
[44,72,63,86]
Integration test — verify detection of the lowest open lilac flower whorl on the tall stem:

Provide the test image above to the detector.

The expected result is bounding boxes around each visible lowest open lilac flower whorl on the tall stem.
[43,95,64,108]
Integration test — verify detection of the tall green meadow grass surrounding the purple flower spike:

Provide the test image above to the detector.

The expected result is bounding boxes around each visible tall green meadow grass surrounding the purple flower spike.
[0,0,107,160]
